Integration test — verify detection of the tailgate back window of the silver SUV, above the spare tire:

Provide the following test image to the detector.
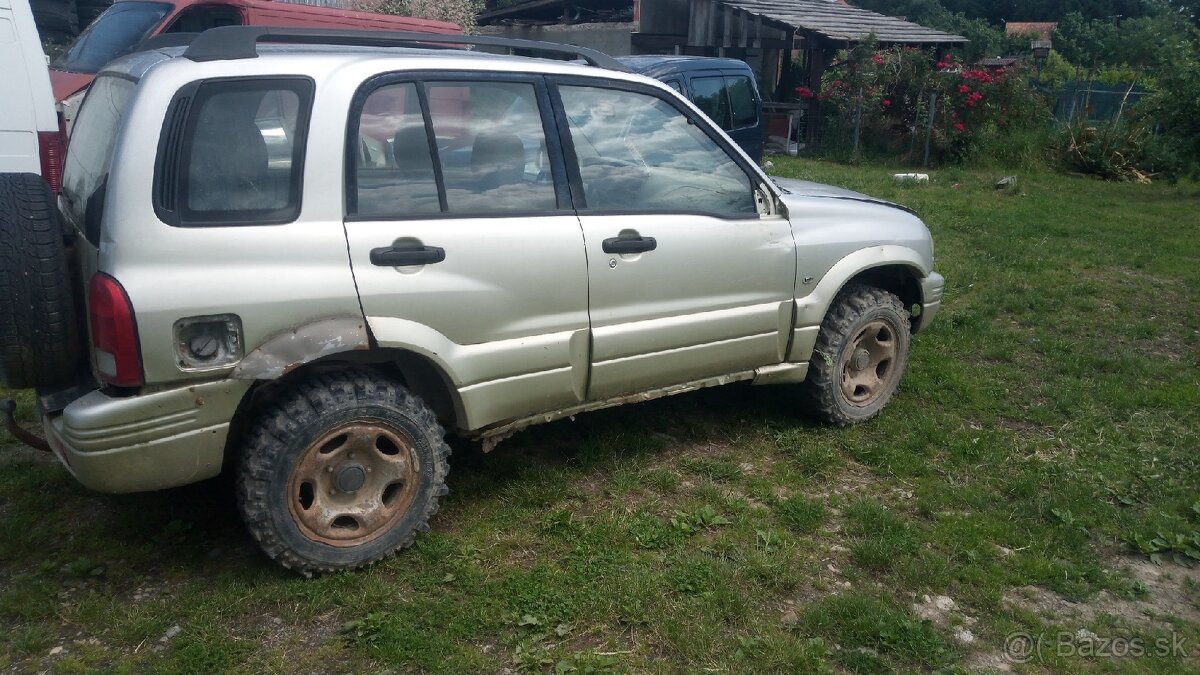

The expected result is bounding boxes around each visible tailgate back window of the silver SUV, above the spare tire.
[62,76,136,227]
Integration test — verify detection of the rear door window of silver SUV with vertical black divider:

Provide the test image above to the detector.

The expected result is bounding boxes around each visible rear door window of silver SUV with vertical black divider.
[347,80,558,220]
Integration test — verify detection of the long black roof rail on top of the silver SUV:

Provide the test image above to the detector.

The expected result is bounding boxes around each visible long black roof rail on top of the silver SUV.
[184,25,632,72]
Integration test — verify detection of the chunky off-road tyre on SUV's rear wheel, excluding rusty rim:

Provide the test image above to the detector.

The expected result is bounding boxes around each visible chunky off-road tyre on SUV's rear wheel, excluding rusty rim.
[235,370,450,575]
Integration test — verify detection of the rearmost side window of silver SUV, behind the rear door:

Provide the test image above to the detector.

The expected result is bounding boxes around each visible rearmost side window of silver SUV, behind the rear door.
[155,78,312,227]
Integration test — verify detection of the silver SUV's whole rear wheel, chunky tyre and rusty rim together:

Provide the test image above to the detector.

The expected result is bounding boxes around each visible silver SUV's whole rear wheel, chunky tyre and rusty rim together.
[238,371,450,574]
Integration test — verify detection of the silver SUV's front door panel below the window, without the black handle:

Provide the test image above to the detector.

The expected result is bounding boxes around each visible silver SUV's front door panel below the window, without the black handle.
[580,211,796,399]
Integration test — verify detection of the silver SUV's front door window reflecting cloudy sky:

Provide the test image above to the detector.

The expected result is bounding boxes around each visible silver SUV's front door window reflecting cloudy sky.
[560,86,757,217]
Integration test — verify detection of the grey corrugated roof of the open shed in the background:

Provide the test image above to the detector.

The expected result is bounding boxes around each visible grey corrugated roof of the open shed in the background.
[720,0,967,44]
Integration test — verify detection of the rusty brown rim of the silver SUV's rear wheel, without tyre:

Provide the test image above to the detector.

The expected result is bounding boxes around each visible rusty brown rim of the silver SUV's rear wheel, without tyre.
[288,422,421,548]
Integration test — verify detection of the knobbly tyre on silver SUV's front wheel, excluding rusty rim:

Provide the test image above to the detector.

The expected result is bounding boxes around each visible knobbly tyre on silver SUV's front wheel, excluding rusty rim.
[802,283,912,426]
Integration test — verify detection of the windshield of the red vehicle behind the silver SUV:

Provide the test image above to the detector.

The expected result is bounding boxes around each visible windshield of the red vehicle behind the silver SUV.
[54,2,172,72]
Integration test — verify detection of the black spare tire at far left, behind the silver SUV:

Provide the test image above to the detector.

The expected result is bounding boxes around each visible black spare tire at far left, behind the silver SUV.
[0,173,83,389]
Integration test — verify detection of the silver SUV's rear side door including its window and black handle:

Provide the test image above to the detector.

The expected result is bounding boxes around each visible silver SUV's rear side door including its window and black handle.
[346,74,588,428]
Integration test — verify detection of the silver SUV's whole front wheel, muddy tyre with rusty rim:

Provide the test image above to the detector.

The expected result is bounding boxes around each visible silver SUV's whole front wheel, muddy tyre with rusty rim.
[803,285,912,426]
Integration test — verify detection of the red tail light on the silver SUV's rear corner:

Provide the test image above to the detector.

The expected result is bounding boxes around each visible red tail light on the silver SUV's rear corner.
[88,273,142,387]
